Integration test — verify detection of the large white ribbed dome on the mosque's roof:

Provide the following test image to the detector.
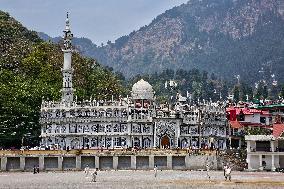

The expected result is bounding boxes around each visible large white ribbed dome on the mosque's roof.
[131,79,154,100]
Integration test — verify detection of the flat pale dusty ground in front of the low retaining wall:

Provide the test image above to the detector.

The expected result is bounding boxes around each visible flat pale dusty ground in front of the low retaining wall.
[0,171,284,189]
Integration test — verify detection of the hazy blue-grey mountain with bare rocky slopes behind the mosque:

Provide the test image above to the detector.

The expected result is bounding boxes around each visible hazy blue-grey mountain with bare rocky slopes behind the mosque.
[71,0,284,83]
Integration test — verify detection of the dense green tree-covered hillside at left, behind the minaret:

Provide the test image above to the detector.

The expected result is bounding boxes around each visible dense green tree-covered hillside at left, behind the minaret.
[0,11,123,148]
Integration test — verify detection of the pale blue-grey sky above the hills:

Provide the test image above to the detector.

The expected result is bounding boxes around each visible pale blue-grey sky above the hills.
[0,0,188,45]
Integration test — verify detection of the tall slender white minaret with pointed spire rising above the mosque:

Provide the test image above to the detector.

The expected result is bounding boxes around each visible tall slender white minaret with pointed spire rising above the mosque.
[61,12,74,103]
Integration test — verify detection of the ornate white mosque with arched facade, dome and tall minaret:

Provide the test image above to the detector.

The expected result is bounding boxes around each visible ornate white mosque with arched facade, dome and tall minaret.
[40,15,229,149]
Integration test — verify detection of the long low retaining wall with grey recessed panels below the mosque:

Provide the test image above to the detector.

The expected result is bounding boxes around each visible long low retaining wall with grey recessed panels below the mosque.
[0,154,224,171]
